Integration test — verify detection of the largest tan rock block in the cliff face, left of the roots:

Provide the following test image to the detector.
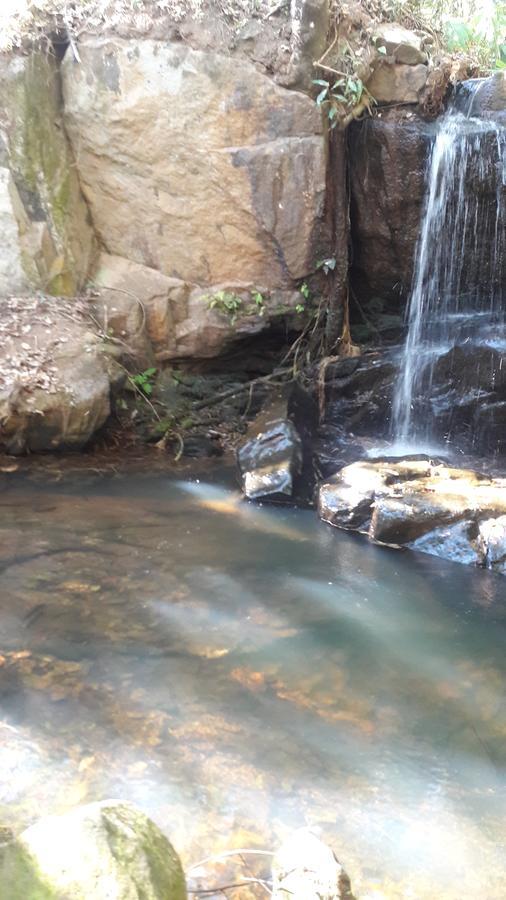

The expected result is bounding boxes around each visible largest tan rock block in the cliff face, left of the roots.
[63,39,325,288]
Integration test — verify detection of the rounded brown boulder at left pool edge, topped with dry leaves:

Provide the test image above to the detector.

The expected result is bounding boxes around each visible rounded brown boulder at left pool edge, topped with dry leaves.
[0,296,118,453]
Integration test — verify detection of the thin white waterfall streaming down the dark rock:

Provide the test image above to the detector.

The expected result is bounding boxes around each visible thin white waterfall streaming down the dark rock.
[392,91,506,449]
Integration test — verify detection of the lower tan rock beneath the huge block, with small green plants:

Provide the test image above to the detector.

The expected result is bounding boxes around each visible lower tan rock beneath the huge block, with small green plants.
[93,253,301,368]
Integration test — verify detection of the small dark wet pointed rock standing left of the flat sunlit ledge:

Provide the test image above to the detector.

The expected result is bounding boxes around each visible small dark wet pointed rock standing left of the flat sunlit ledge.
[237,385,316,500]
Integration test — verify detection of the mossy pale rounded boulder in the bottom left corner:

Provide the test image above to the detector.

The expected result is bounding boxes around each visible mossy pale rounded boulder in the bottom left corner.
[0,800,186,900]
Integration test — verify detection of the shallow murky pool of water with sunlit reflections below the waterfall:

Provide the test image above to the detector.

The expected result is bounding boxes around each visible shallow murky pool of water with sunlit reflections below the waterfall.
[0,475,506,900]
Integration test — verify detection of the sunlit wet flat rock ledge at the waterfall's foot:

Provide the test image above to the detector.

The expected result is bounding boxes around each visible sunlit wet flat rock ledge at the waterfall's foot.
[318,458,506,575]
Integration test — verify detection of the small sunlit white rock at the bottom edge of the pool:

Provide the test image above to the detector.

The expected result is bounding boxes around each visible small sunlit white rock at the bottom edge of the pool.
[272,828,354,900]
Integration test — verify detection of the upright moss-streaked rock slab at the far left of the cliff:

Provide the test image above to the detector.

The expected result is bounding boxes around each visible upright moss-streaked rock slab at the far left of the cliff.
[0,52,94,296]
